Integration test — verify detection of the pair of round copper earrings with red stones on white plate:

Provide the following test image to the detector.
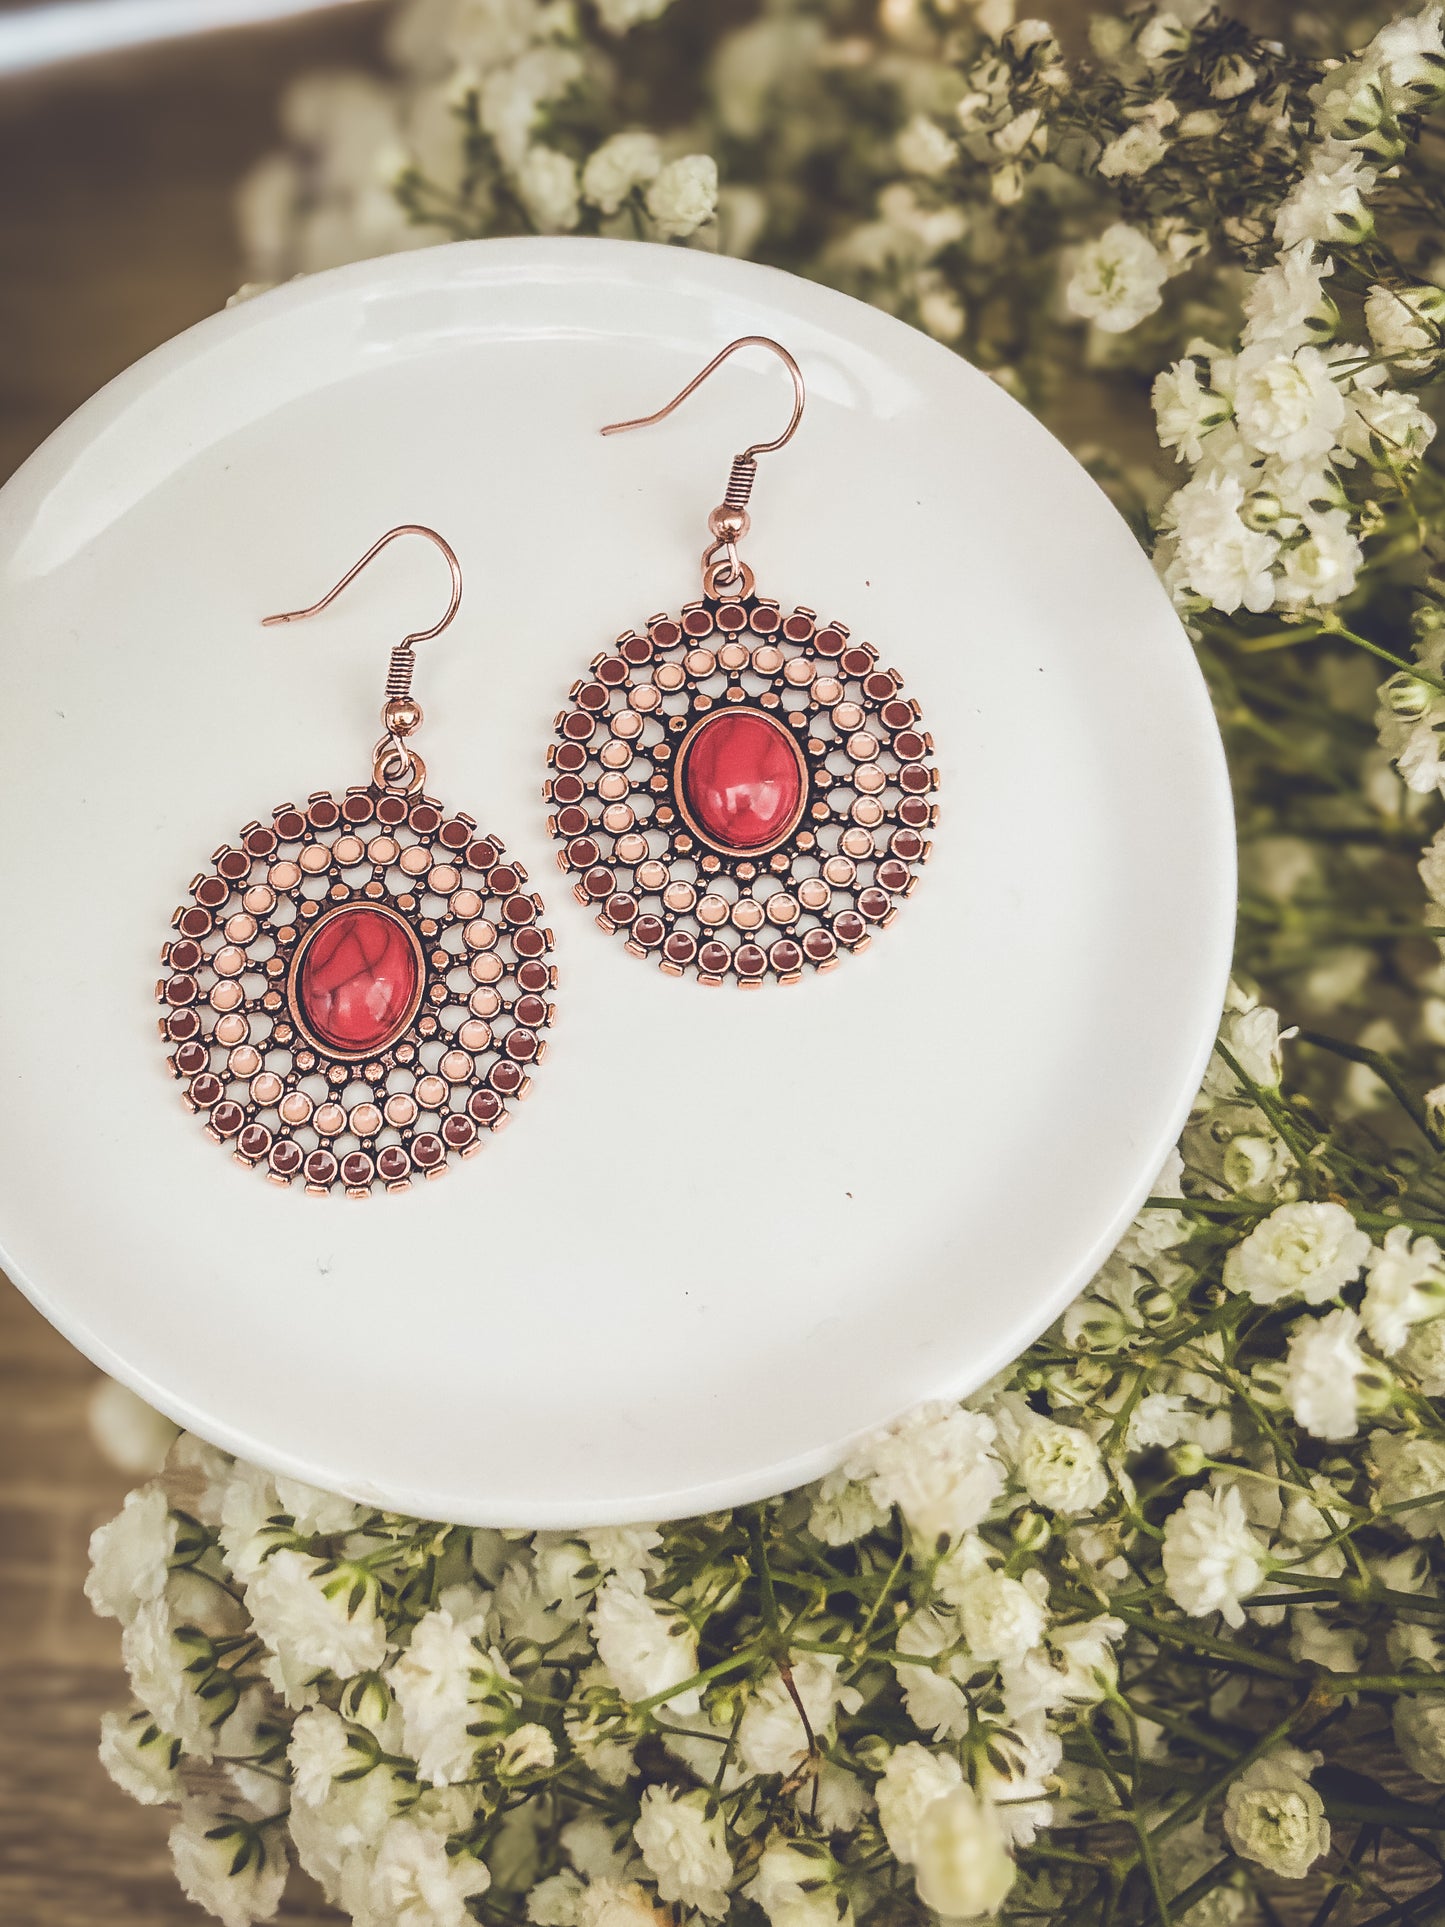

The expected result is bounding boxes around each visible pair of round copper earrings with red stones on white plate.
[156,335,936,1197]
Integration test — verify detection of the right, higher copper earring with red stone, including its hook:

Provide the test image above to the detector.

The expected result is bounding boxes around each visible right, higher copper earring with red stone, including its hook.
[545,335,936,989]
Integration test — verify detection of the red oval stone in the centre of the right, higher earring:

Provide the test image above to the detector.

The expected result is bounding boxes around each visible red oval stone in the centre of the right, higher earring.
[676,709,805,852]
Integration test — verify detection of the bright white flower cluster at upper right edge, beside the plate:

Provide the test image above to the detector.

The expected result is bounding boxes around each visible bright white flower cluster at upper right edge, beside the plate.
[1156,6,1445,615]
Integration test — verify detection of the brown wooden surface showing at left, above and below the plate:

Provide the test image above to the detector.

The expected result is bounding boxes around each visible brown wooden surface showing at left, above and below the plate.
[0,10,385,1927]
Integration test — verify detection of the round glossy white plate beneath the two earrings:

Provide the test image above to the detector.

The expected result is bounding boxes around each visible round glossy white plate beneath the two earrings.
[0,241,1233,1526]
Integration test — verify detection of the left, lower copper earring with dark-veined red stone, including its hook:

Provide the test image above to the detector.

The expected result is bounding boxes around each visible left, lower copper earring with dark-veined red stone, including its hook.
[156,524,557,1197]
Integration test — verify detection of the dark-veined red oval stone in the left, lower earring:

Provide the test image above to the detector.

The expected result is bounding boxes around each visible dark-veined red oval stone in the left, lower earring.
[291,904,422,1056]
